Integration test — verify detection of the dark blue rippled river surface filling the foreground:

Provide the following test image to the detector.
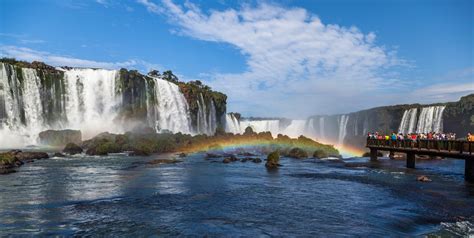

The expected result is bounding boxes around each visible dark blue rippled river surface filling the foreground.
[0,154,474,237]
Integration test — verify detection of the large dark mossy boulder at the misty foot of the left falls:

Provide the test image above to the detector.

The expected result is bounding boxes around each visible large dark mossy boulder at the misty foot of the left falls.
[39,130,82,146]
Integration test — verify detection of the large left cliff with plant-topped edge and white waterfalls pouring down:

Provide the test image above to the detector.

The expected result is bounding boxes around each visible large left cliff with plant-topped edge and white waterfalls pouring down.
[0,58,227,136]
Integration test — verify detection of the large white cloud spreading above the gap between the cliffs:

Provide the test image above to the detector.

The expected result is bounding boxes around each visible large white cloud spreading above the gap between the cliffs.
[139,0,412,117]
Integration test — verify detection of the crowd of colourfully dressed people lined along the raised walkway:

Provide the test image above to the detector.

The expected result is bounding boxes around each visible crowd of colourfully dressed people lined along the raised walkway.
[367,132,474,142]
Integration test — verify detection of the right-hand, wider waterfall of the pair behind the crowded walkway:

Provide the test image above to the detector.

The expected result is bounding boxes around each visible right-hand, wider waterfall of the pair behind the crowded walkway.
[416,106,446,133]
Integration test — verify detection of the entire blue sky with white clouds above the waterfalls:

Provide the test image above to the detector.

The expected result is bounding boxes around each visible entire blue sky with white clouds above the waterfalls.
[0,0,474,118]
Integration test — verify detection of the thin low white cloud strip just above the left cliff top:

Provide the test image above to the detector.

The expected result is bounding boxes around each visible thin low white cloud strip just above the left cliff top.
[0,45,162,71]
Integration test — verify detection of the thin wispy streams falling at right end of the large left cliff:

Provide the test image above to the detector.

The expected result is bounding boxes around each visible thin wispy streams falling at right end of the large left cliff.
[197,94,217,135]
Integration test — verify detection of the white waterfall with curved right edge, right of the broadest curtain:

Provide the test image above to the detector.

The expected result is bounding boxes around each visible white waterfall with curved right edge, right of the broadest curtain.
[147,78,191,134]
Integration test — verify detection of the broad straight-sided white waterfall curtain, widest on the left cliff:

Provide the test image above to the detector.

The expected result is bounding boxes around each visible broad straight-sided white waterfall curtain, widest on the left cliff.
[64,69,122,138]
